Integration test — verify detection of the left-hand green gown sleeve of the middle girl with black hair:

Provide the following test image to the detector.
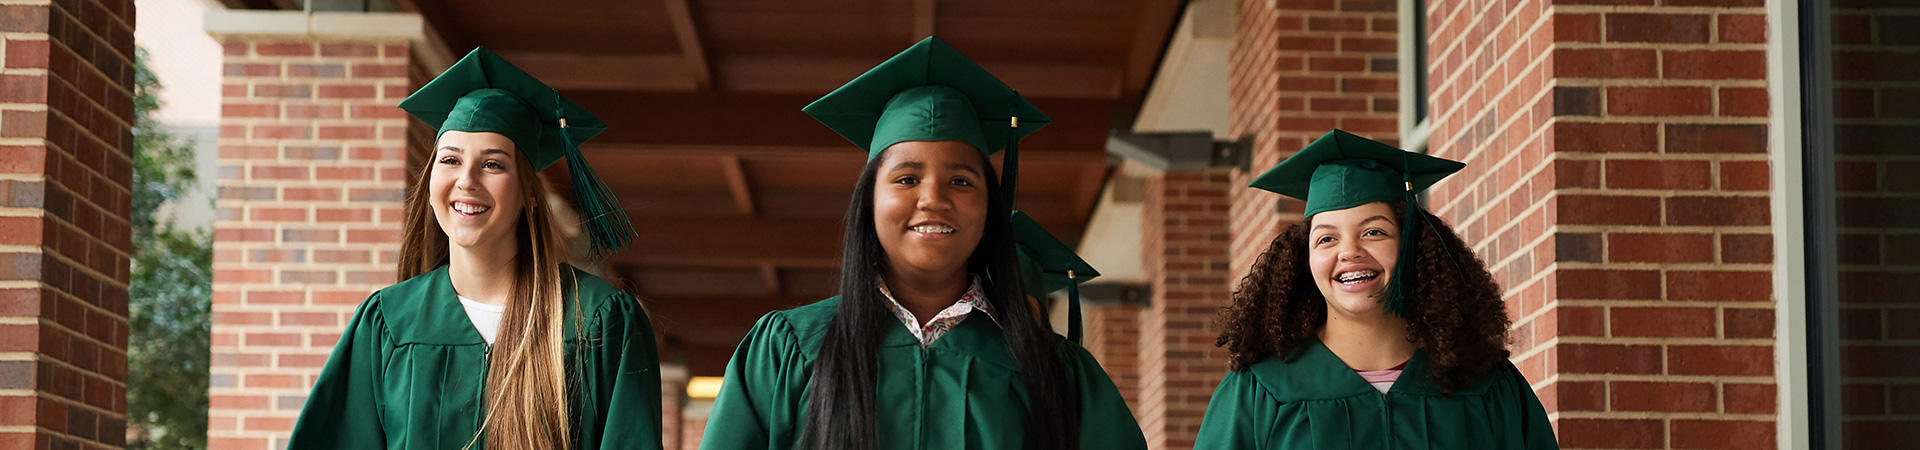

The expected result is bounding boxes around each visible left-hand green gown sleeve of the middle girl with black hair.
[701,312,808,450]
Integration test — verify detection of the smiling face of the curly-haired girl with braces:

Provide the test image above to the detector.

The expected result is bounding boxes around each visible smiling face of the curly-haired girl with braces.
[1308,202,1400,317]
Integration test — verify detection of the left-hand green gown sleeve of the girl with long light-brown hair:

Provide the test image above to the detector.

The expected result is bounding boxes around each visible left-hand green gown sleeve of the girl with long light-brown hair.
[286,292,386,450]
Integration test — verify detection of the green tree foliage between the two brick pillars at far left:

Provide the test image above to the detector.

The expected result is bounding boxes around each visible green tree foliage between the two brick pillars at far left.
[127,48,213,450]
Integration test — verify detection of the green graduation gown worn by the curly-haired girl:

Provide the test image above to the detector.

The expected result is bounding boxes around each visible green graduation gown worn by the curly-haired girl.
[1194,340,1559,450]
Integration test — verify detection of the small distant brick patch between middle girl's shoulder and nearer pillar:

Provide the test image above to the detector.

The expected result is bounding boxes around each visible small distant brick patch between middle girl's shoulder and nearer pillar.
[1081,304,1142,407]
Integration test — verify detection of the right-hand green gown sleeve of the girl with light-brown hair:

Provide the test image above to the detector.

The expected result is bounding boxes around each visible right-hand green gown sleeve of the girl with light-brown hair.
[578,292,660,450]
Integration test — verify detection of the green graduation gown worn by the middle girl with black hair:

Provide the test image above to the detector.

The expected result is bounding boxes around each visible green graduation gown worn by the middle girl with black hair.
[701,298,1146,450]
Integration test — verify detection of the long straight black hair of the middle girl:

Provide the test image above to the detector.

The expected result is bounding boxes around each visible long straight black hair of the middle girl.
[799,150,1081,450]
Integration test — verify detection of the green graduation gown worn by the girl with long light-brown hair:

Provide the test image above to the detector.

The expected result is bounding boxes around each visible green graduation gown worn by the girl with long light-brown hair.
[288,265,660,450]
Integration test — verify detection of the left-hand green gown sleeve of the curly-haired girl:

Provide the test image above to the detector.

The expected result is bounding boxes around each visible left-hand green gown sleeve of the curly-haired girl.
[1194,371,1273,450]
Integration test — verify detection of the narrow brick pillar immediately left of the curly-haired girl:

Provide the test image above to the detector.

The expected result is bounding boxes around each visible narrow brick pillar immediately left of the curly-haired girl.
[1135,167,1235,448]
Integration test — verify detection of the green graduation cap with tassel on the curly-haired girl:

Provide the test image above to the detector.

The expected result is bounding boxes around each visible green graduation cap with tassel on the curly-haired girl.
[1248,129,1467,315]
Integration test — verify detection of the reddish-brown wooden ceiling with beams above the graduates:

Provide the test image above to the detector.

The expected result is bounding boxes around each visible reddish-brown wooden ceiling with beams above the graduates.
[228,0,1183,375]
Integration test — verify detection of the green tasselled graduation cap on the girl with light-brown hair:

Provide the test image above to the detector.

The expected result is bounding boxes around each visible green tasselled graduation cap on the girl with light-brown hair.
[399,48,634,258]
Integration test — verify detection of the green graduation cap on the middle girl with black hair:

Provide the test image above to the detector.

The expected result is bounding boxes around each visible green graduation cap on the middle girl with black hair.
[801,37,1052,199]
